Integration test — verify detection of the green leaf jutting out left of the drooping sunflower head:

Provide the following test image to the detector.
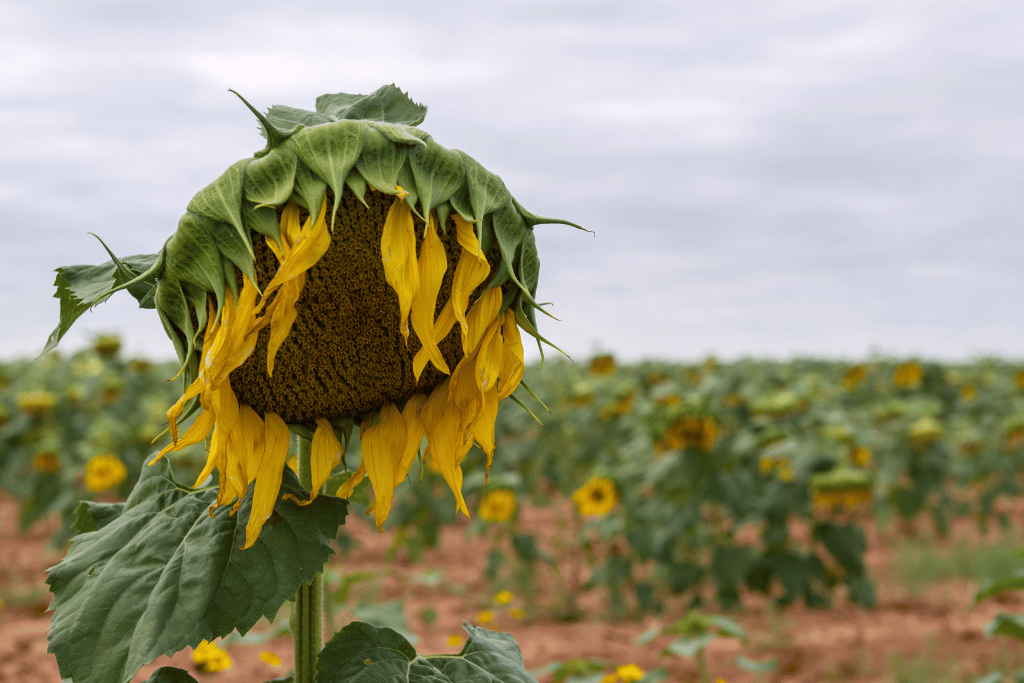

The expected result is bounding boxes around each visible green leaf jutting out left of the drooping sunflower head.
[40,254,160,355]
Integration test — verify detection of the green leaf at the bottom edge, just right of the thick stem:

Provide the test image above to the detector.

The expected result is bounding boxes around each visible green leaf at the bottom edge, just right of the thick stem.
[316,622,537,683]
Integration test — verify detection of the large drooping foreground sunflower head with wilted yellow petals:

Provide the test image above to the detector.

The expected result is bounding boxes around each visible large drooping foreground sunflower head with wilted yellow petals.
[51,85,571,548]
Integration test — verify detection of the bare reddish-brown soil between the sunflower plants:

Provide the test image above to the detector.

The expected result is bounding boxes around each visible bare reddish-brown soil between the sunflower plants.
[0,497,1024,683]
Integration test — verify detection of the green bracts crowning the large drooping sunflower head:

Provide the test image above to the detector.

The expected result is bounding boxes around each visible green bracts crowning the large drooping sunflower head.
[44,85,582,397]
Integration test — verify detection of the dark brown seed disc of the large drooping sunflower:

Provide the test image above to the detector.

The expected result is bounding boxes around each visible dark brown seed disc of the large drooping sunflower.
[230,187,500,426]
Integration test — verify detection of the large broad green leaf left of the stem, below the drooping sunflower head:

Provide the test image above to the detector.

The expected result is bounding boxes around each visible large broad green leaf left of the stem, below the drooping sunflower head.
[46,460,346,683]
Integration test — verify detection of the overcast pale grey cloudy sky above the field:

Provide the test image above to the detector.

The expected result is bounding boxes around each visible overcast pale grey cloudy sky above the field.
[0,0,1024,359]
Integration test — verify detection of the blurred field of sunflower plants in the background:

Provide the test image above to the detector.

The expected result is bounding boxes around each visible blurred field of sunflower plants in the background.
[8,336,1024,616]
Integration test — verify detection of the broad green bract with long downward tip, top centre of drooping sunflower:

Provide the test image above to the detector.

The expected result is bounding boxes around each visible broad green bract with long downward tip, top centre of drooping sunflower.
[279,121,367,230]
